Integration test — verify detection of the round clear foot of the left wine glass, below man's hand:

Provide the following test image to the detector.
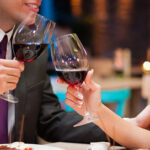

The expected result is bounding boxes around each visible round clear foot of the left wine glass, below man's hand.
[0,92,19,103]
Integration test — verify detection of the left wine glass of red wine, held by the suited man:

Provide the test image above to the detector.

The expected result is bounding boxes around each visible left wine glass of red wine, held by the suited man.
[3,13,55,103]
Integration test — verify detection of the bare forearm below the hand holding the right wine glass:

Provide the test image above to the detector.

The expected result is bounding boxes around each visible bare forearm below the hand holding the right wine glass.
[95,104,150,148]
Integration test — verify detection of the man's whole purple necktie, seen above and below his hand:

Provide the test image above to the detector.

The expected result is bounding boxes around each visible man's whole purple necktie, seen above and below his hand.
[0,35,8,143]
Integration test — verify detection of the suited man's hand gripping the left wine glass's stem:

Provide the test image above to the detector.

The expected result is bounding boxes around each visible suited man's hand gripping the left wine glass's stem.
[0,59,24,94]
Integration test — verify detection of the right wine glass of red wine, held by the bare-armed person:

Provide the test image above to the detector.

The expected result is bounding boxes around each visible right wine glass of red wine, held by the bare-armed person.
[51,33,96,127]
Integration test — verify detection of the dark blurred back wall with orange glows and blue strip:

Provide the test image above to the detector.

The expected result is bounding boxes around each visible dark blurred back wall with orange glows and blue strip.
[41,0,150,65]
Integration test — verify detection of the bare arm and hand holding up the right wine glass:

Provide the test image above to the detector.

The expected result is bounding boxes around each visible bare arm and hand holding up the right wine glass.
[66,71,150,148]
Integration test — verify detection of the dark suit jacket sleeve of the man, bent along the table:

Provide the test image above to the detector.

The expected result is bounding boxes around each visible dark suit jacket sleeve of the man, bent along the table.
[38,75,106,143]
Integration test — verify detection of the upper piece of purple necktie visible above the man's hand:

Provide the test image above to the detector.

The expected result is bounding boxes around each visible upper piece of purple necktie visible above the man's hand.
[0,35,8,59]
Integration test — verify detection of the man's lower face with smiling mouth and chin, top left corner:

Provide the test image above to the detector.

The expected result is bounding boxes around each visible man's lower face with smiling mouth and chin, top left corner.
[0,0,42,29]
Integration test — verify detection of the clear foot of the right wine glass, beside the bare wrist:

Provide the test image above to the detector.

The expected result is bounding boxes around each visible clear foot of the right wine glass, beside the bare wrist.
[73,115,98,127]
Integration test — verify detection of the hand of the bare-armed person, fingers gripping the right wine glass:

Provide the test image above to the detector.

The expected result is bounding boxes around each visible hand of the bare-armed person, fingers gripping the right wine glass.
[57,70,101,116]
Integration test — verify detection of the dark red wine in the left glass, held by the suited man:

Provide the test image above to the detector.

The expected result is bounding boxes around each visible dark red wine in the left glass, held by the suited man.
[13,43,48,62]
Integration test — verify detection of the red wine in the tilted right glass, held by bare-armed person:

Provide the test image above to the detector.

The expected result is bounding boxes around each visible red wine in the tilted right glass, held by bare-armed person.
[56,70,87,85]
